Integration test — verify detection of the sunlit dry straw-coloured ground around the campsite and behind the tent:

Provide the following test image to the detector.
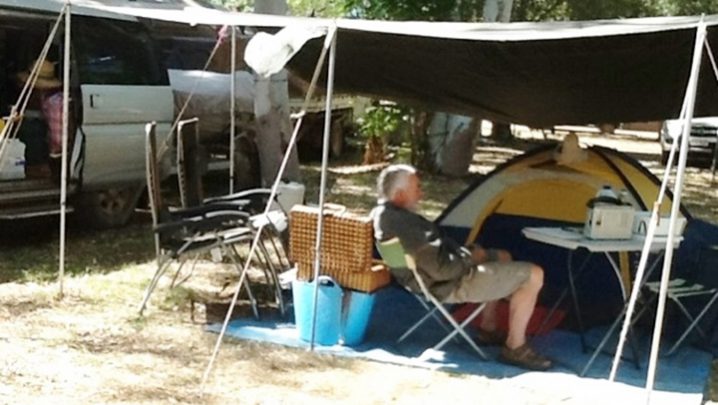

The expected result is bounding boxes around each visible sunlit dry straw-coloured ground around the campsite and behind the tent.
[0,130,718,404]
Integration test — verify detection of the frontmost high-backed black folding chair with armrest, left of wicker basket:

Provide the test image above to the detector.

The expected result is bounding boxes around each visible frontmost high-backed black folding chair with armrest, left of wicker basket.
[139,123,259,317]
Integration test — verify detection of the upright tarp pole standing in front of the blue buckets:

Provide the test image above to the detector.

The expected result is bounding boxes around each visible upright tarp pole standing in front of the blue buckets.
[309,27,337,350]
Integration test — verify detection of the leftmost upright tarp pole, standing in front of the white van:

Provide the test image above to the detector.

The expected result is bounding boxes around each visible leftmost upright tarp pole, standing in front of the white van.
[58,0,72,298]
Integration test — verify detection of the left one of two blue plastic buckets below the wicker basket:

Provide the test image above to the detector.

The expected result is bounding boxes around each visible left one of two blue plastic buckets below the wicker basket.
[292,276,342,346]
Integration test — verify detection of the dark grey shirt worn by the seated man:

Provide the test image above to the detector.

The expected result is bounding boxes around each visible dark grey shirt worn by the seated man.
[372,203,473,300]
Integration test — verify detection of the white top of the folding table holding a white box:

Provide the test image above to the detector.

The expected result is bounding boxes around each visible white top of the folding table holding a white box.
[522,227,683,252]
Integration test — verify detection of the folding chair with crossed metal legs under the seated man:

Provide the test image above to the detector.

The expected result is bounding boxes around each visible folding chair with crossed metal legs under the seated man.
[377,238,486,360]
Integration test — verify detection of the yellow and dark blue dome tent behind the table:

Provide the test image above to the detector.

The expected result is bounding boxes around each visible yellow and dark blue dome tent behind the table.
[436,140,690,321]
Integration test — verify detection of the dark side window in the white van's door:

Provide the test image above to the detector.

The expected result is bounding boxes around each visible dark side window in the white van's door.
[73,18,168,85]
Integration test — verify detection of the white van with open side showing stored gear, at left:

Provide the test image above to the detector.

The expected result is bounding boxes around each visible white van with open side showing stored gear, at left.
[0,0,225,227]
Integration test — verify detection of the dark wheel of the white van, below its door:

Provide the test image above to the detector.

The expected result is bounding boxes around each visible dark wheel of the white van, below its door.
[80,186,142,229]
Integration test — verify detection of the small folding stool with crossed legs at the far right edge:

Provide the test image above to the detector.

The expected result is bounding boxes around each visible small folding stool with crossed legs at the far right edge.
[646,278,718,356]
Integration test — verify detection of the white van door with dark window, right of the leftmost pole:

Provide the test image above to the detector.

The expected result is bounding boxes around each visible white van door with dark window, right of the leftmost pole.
[73,17,174,190]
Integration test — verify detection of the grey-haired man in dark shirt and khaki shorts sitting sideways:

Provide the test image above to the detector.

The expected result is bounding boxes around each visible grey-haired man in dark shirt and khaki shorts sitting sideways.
[372,165,552,370]
